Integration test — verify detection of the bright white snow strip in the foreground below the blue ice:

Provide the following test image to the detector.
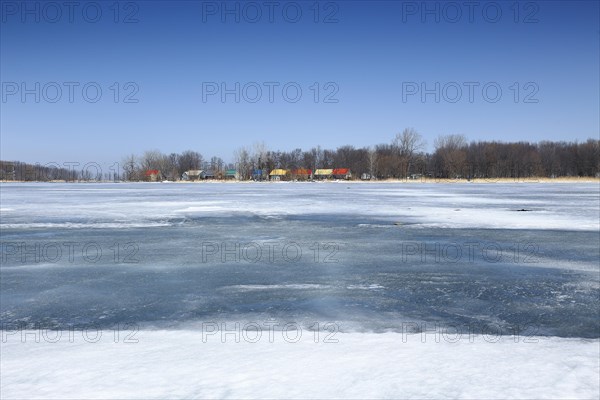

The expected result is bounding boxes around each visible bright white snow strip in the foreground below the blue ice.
[1,330,600,399]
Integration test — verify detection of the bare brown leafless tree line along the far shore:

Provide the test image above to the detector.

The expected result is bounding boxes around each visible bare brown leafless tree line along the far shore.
[0,128,600,181]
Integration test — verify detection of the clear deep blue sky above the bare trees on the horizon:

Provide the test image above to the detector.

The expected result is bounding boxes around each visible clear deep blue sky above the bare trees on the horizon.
[0,0,600,164]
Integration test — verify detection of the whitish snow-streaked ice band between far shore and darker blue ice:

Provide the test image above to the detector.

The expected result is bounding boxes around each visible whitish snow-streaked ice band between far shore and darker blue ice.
[0,183,600,232]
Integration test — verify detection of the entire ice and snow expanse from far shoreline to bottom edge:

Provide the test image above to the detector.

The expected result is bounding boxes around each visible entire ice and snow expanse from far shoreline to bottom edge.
[0,182,600,399]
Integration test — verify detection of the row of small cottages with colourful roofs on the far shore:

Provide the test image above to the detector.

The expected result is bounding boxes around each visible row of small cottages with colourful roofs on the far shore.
[145,168,352,181]
